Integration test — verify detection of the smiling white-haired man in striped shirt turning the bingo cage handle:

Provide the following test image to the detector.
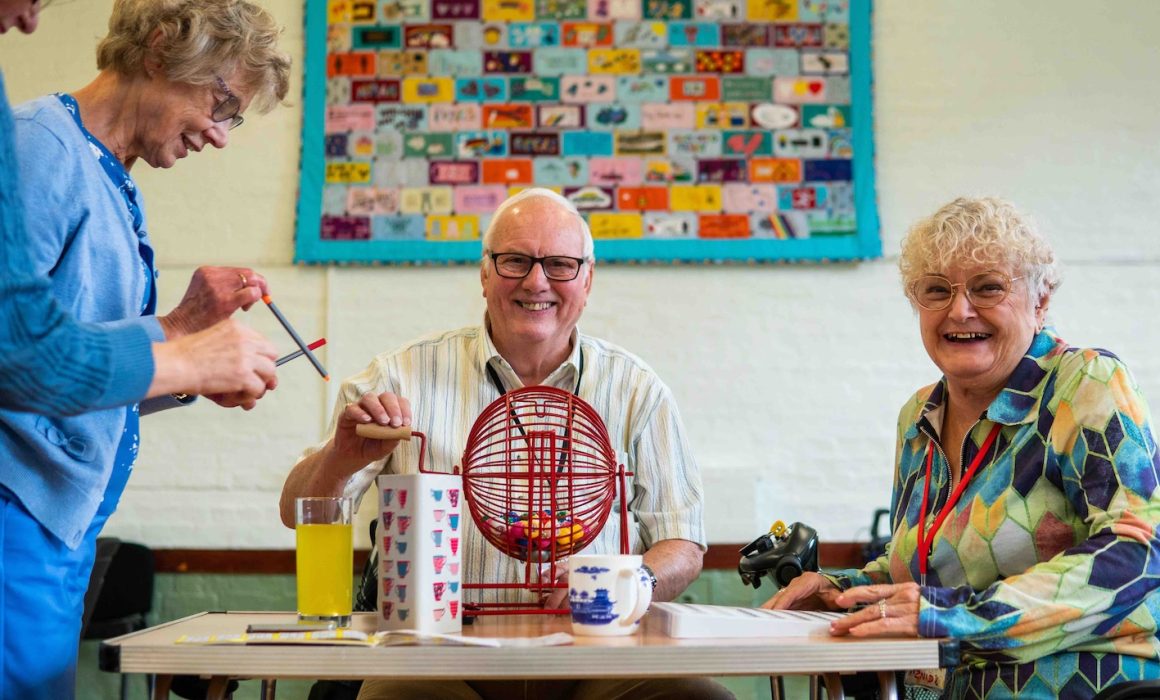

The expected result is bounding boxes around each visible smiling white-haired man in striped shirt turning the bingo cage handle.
[281,188,732,700]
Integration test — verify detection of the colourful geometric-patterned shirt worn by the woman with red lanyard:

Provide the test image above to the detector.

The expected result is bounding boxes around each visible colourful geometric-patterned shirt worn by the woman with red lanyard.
[834,331,1160,698]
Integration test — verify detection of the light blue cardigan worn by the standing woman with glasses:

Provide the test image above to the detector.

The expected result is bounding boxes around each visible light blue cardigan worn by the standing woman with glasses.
[0,91,164,547]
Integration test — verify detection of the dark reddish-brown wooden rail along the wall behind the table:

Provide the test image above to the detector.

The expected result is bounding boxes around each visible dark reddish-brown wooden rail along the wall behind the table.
[153,542,862,573]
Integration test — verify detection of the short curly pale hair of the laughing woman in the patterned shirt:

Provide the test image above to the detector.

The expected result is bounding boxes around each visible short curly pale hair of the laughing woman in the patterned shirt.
[898,197,1060,306]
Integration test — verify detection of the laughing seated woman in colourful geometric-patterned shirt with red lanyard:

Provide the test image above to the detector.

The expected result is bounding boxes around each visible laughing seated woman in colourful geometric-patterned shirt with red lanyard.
[764,199,1160,698]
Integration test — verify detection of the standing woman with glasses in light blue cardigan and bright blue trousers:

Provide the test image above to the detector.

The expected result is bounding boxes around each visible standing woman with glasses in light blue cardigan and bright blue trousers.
[0,0,289,698]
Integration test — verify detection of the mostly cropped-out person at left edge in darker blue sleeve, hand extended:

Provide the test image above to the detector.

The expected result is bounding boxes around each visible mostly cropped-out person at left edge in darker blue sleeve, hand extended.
[0,0,276,416]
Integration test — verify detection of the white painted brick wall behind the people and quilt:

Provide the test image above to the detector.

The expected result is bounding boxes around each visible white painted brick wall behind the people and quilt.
[0,0,1160,548]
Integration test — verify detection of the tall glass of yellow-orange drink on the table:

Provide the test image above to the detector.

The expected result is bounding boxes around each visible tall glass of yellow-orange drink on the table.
[295,497,354,627]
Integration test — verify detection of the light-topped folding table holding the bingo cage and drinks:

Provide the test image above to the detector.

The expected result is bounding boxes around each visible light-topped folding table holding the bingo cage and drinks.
[100,612,958,699]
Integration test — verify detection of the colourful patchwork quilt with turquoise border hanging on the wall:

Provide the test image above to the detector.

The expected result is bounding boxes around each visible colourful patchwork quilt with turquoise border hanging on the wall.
[296,0,882,264]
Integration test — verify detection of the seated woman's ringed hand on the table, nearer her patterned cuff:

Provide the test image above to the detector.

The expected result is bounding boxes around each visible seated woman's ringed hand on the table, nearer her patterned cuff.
[829,582,922,637]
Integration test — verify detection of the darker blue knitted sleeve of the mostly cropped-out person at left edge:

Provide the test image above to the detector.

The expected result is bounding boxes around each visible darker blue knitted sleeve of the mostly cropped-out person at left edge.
[0,73,153,414]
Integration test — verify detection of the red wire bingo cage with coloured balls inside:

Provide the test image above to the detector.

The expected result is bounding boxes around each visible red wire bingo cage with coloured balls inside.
[459,387,631,614]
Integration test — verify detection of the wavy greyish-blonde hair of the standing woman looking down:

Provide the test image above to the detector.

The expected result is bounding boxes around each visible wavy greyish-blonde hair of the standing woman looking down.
[96,0,290,113]
